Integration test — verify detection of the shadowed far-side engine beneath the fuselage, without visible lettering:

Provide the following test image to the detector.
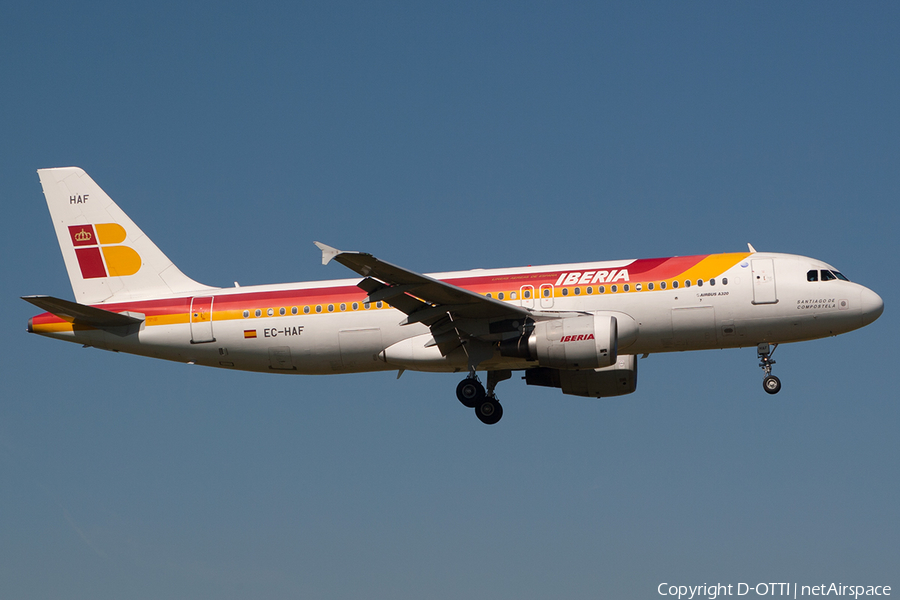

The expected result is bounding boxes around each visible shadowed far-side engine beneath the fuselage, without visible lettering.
[525,354,637,398]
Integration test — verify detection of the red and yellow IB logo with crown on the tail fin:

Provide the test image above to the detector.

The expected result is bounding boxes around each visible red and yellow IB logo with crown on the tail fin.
[69,223,141,279]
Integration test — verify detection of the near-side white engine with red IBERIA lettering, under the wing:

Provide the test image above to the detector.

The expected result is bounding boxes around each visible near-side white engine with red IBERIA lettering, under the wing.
[500,315,618,370]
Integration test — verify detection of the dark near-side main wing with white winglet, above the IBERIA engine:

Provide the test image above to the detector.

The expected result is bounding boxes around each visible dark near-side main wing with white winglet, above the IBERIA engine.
[315,242,531,329]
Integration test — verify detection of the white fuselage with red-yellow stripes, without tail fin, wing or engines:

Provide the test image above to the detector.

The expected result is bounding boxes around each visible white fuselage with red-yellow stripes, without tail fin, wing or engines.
[29,253,883,374]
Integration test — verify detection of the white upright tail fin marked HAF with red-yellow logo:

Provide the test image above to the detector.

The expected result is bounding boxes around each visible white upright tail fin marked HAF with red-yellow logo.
[38,167,211,304]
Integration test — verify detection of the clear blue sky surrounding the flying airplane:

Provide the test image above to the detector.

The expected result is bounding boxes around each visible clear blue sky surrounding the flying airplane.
[0,2,900,599]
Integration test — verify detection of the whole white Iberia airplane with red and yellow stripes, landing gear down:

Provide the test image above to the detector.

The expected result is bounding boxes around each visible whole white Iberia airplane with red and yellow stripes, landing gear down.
[23,167,884,425]
